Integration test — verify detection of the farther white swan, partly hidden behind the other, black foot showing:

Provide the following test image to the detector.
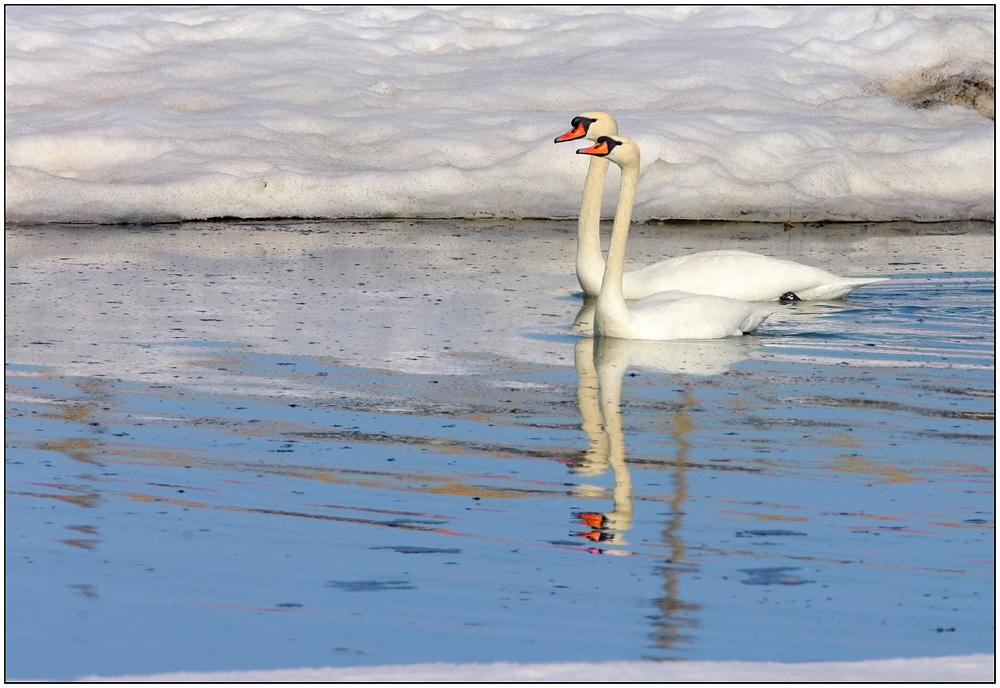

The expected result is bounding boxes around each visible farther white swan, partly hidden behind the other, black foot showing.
[555,112,888,301]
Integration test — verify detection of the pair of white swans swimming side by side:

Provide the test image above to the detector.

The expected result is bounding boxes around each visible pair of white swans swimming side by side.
[555,112,884,340]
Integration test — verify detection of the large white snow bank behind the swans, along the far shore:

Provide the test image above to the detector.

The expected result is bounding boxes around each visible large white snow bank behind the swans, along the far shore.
[4,6,994,226]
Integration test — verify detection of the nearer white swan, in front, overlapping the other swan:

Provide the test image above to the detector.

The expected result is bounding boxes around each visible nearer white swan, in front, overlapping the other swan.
[577,136,787,340]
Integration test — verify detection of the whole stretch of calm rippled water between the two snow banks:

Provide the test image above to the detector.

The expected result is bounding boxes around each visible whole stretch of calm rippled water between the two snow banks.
[5,223,994,679]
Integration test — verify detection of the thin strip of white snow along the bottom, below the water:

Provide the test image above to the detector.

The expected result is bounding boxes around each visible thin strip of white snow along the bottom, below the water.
[80,655,995,683]
